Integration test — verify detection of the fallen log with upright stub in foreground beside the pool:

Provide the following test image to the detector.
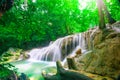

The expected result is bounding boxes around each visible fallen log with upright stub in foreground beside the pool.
[42,61,93,80]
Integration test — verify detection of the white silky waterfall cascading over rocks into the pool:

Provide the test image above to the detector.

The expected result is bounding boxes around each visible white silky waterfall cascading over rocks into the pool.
[28,33,86,61]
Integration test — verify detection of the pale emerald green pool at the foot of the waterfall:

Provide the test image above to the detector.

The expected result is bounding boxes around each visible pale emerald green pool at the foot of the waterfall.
[11,60,56,80]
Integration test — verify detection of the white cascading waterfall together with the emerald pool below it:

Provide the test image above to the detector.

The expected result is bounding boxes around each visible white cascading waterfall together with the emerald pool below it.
[12,33,86,80]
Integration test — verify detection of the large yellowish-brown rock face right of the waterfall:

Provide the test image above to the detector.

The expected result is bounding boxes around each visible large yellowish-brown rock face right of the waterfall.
[76,23,120,78]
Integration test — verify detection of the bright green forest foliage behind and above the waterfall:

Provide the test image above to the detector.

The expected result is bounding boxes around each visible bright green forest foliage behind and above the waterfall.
[0,0,120,54]
